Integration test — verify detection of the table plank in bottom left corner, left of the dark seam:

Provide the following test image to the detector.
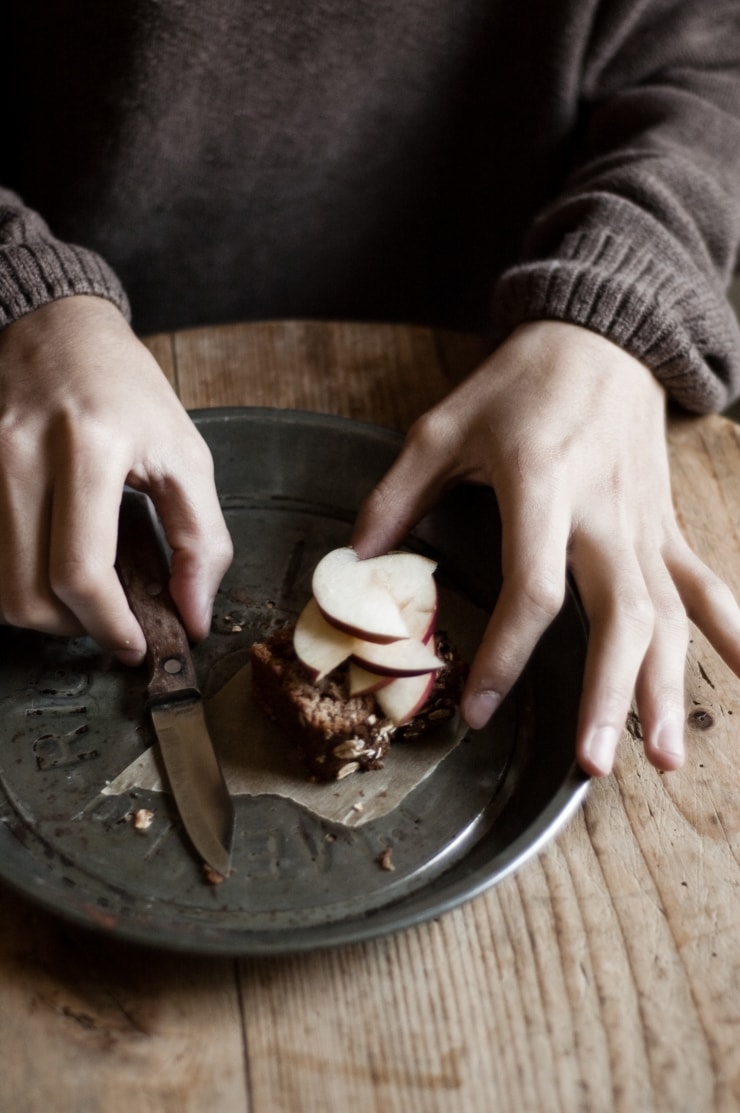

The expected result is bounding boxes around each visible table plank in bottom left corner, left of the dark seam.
[0,890,246,1113]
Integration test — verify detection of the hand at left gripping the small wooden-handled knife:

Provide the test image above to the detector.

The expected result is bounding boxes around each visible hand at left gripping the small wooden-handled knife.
[0,296,231,663]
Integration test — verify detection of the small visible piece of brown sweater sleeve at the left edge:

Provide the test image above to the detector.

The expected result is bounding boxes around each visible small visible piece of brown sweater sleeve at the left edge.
[0,189,130,328]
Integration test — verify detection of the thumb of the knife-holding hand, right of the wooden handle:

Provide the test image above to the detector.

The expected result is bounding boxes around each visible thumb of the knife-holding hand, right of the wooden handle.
[149,442,234,641]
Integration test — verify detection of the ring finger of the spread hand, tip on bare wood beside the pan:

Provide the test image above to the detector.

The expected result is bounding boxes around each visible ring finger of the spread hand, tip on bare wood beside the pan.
[635,561,689,772]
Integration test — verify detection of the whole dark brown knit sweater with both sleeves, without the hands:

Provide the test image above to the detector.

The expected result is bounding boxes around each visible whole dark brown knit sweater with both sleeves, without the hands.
[0,0,740,411]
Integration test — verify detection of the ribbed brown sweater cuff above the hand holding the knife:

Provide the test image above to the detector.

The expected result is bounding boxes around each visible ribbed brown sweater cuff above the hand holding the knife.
[0,239,130,328]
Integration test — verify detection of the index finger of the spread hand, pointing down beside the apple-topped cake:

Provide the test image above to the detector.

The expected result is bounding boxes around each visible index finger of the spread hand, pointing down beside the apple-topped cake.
[461,492,570,729]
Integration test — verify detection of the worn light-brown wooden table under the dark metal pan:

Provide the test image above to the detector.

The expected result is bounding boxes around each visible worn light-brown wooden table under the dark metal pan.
[0,323,740,1113]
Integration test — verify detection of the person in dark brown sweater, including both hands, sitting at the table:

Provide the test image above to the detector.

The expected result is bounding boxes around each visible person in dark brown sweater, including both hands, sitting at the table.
[0,0,740,775]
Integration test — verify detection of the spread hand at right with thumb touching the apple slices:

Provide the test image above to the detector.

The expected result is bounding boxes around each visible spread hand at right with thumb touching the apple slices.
[353,322,740,775]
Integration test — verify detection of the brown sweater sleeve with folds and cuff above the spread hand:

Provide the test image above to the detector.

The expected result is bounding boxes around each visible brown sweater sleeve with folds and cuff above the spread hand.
[494,0,740,412]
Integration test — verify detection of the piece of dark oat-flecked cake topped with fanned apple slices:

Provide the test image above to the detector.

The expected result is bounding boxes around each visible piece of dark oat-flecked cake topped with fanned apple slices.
[251,549,466,780]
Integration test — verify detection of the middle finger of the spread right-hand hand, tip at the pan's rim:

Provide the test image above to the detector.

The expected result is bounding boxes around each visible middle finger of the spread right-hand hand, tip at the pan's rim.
[573,539,653,776]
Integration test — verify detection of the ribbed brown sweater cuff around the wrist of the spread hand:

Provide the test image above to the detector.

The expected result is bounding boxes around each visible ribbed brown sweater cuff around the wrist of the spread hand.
[494,229,739,412]
